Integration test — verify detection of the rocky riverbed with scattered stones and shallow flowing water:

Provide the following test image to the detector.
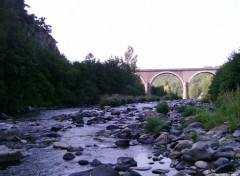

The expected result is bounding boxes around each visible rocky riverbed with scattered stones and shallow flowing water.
[0,100,240,176]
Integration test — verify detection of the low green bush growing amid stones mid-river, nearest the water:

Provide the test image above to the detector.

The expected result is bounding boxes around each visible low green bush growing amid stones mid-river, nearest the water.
[144,117,165,133]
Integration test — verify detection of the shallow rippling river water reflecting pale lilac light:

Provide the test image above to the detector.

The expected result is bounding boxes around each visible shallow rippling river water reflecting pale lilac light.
[0,104,176,176]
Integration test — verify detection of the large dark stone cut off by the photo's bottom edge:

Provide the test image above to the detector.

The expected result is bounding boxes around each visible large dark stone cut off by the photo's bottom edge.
[70,165,120,176]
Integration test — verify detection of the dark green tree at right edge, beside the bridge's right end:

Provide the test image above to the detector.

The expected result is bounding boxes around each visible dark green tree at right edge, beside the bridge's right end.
[209,52,240,101]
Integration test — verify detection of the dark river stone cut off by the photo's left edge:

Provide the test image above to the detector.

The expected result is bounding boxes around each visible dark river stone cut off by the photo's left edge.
[0,145,23,163]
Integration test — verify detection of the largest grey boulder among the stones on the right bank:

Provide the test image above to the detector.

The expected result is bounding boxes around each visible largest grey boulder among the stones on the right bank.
[182,141,215,161]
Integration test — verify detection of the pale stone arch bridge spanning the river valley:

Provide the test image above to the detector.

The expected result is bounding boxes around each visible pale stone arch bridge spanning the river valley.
[136,67,218,99]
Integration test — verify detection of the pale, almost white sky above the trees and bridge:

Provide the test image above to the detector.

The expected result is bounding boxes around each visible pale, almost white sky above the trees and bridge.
[25,0,240,69]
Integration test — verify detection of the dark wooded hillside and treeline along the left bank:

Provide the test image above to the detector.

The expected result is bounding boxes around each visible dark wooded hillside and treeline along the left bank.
[0,0,144,113]
